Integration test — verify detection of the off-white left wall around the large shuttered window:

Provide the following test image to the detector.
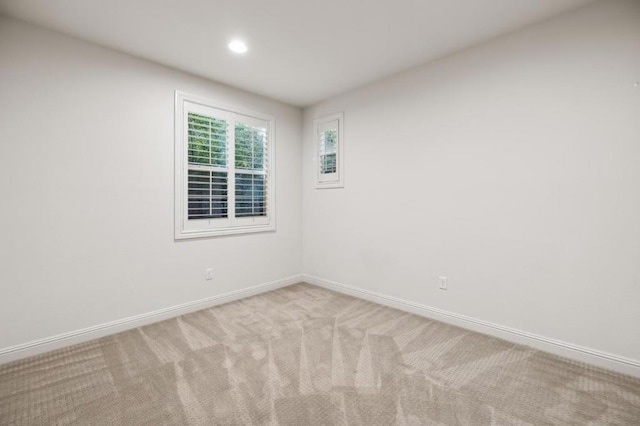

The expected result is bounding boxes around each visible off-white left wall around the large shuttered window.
[0,18,302,349]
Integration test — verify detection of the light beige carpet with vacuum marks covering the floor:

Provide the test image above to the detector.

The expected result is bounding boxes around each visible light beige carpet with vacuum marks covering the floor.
[0,284,640,426]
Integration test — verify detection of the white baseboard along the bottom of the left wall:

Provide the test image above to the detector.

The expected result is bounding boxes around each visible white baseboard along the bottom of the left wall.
[0,275,303,364]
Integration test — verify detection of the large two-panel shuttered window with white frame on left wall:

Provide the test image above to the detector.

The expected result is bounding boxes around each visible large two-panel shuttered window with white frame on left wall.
[175,92,275,239]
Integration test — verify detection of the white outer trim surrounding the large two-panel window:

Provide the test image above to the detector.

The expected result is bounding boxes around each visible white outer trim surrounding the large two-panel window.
[174,90,276,240]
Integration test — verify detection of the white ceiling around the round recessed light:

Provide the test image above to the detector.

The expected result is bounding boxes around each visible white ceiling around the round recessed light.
[0,0,594,106]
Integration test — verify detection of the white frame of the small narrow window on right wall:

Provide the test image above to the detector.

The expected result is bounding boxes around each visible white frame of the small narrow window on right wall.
[313,112,344,189]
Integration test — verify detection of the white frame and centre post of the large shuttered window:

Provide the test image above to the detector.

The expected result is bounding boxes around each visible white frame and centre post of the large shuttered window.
[174,90,276,240]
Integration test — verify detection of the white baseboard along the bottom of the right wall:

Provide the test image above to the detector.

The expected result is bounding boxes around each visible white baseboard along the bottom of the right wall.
[303,275,640,377]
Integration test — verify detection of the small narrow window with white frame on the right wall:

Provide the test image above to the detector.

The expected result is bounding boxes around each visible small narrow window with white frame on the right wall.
[314,113,344,188]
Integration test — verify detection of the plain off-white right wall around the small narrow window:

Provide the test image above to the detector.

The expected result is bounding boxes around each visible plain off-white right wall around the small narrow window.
[303,0,640,361]
